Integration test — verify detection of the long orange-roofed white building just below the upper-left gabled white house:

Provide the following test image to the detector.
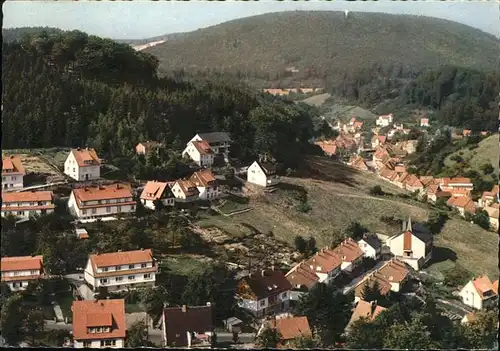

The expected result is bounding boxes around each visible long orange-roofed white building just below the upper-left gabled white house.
[68,184,136,218]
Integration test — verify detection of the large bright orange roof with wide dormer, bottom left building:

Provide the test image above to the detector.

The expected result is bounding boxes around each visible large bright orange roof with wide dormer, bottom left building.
[71,299,127,340]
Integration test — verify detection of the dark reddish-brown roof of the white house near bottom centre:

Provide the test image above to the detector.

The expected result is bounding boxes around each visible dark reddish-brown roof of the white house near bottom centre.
[240,269,292,300]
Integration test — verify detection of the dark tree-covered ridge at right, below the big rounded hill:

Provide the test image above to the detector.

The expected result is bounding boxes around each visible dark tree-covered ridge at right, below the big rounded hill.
[326,65,500,132]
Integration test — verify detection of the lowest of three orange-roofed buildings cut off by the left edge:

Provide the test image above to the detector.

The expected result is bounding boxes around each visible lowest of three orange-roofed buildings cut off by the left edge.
[0,255,44,291]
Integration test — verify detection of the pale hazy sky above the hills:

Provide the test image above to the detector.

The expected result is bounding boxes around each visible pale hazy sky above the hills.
[3,0,500,39]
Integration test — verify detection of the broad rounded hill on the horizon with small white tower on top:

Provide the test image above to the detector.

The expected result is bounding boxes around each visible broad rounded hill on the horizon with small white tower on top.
[147,11,500,79]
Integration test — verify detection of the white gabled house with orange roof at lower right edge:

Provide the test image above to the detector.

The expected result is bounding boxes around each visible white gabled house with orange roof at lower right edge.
[460,275,498,310]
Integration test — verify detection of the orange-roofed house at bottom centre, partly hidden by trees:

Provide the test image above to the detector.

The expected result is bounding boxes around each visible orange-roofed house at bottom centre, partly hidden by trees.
[257,316,312,348]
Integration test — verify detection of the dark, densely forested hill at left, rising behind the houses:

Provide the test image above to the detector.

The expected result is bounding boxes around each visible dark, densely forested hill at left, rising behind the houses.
[2,31,326,168]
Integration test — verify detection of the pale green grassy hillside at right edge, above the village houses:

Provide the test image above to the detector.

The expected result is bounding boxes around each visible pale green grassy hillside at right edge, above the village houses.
[445,134,500,173]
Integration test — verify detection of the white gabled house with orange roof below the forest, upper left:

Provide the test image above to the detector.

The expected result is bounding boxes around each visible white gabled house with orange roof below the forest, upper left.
[64,148,101,181]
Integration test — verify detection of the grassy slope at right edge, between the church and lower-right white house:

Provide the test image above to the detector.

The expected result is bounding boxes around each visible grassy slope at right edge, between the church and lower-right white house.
[429,219,498,279]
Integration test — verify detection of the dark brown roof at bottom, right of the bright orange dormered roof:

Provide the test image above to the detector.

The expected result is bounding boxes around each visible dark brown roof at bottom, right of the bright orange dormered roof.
[164,306,214,347]
